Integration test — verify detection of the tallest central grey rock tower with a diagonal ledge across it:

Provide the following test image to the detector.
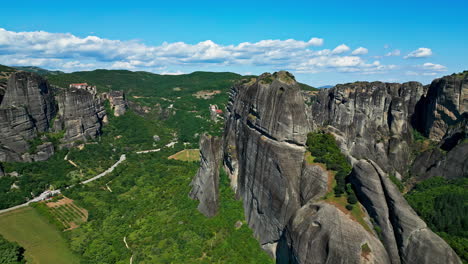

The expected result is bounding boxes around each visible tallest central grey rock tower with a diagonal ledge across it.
[224,72,310,249]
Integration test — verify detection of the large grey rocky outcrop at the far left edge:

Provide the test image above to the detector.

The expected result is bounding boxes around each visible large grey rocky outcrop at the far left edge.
[0,72,57,161]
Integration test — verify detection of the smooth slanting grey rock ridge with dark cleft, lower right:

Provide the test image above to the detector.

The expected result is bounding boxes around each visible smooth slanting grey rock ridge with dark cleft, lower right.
[351,160,461,263]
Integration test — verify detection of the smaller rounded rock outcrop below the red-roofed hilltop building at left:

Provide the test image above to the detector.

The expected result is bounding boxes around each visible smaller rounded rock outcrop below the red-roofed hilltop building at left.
[54,88,106,147]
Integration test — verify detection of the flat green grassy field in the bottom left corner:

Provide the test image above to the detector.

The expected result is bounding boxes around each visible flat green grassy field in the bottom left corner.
[0,207,79,264]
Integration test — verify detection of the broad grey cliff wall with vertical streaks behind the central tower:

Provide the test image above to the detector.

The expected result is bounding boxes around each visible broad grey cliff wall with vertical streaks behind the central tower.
[311,82,425,174]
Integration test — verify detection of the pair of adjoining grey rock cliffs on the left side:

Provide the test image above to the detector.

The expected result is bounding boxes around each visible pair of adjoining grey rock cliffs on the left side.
[0,71,106,162]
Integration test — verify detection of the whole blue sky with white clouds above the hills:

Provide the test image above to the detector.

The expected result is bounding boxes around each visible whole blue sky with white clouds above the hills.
[0,0,468,86]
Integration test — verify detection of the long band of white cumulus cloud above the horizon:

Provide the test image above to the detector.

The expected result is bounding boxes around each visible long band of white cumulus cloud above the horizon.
[0,28,392,74]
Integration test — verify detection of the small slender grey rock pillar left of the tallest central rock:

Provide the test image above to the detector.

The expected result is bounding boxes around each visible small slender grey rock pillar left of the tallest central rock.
[189,135,222,217]
